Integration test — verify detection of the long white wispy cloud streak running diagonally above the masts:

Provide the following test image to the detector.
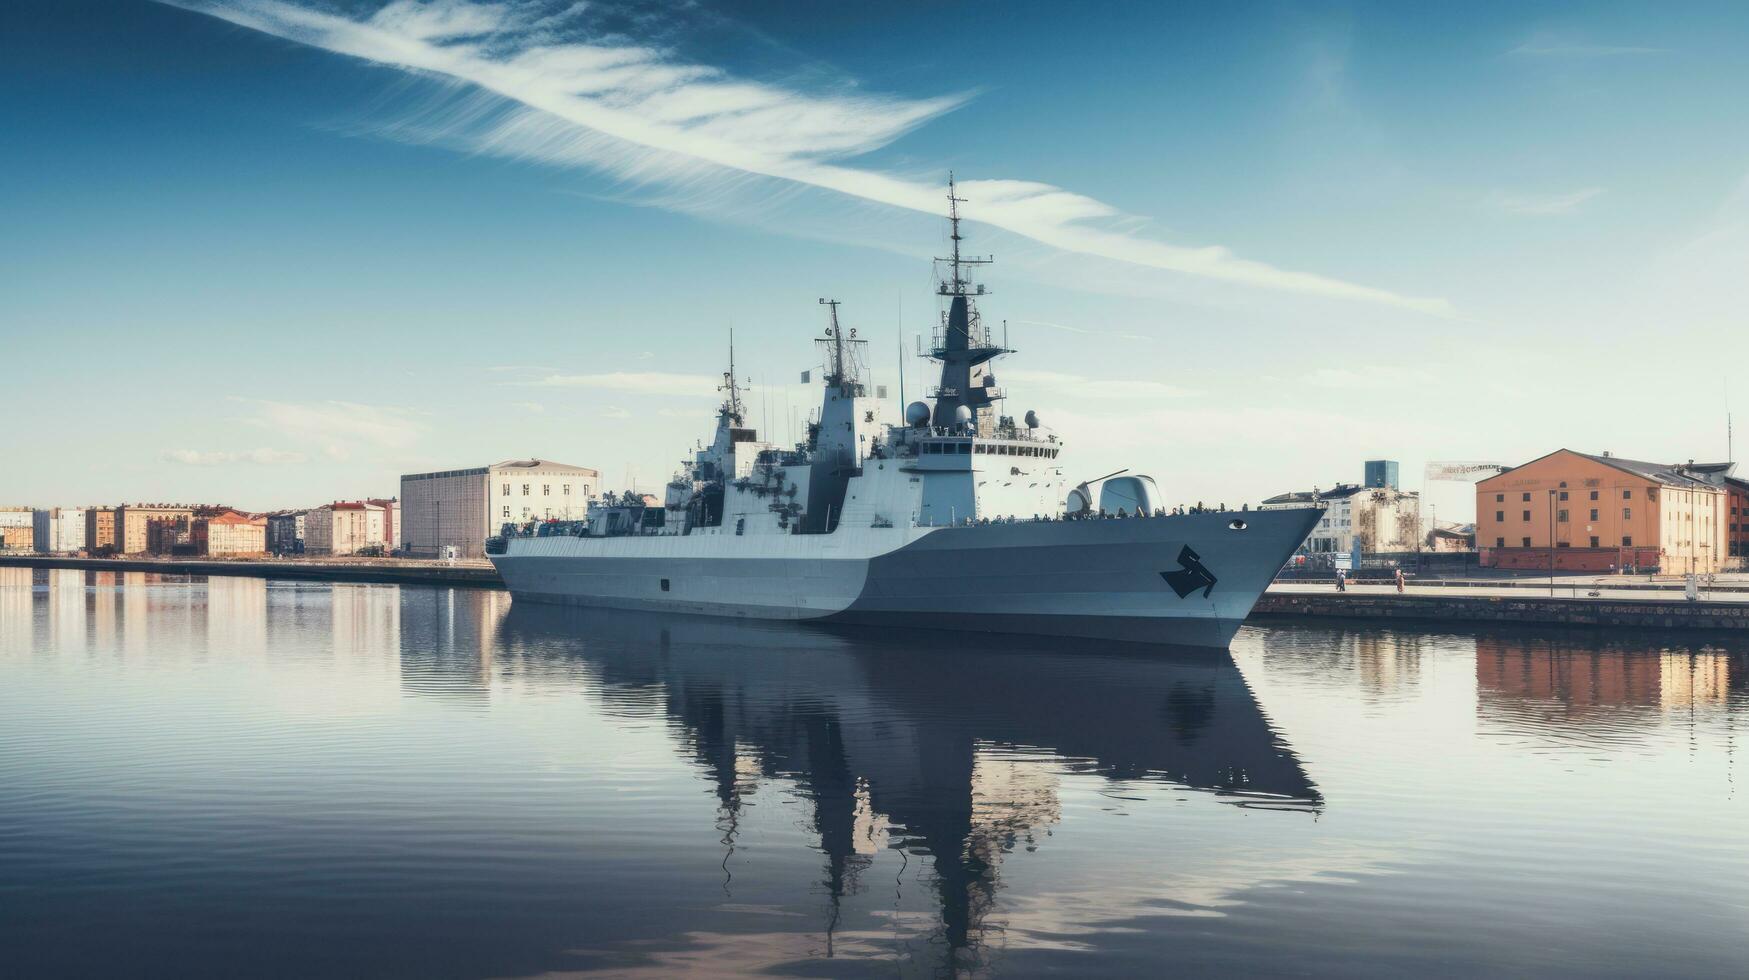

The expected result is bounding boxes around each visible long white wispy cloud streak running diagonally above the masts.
[163,0,1450,315]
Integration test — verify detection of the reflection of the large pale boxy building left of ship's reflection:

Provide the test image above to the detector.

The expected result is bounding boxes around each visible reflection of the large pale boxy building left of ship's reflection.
[397,586,511,704]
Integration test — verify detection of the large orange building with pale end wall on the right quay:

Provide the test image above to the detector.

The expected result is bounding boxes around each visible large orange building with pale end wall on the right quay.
[1476,450,1742,574]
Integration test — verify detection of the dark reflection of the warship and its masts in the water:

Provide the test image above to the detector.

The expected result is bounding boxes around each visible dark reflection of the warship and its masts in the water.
[500,606,1319,970]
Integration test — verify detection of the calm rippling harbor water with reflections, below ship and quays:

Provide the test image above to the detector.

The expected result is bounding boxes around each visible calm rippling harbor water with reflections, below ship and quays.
[0,569,1749,977]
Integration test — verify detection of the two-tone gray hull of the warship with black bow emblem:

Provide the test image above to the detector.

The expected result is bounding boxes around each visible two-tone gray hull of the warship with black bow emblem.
[493,511,1319,648]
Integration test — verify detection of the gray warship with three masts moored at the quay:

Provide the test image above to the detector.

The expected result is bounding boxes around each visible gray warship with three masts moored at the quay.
[486,180,1319,648]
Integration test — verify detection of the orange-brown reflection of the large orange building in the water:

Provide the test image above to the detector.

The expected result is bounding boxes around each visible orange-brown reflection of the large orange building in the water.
[1476,634,1749,718]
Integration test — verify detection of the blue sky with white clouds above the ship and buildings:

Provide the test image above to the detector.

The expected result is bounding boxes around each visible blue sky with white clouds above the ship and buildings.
[0,0,1749,513]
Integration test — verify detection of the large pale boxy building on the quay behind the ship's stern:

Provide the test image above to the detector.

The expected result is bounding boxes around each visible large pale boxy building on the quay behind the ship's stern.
[401,459,602,558]
